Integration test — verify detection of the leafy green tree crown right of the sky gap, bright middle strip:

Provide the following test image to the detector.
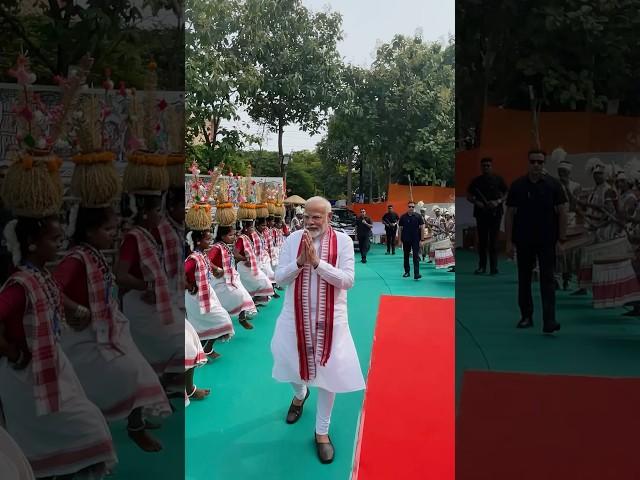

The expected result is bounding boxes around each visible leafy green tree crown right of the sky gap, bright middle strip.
[318,35,455,191]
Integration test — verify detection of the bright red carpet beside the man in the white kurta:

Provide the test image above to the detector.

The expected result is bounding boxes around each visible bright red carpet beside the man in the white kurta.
[352,296,455,480]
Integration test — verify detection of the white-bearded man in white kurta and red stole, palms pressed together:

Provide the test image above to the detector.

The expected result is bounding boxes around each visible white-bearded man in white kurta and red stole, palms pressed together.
[271,197,365,463]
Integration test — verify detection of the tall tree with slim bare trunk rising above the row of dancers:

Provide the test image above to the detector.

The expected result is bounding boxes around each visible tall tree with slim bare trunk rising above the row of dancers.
[234,0,342,171]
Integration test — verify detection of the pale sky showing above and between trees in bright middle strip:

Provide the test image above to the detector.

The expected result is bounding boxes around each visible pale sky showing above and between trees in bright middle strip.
[236,0,455,153]
